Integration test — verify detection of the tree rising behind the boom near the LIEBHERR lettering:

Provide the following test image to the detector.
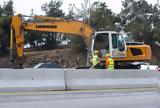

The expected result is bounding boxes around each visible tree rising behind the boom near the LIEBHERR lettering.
[41,0,64,49]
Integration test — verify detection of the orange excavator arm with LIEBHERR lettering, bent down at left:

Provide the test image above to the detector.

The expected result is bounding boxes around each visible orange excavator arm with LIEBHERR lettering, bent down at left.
[10,14,94,65]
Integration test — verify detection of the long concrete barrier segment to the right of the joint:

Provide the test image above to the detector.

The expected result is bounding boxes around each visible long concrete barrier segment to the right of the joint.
[65,69,160,90]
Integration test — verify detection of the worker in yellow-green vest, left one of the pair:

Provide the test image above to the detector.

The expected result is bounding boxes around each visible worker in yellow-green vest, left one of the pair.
[92,50,100,69]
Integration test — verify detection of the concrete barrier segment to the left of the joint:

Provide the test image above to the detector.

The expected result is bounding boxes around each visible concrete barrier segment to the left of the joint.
[0,69,66,92]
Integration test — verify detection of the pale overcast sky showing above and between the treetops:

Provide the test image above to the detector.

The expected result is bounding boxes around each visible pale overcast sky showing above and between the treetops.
[0,0,157,15]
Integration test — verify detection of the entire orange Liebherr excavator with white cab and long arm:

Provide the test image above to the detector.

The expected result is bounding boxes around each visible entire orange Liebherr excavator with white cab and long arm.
[10,14,152,68]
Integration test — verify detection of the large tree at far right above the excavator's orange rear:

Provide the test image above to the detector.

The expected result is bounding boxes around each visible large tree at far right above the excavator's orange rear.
[120,0,160,45]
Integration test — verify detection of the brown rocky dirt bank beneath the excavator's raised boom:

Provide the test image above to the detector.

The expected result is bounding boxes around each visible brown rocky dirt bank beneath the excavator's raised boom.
[23,48,87,68]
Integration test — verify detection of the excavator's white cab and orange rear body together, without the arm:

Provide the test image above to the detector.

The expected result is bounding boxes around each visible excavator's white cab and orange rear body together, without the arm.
[88,31,152,69]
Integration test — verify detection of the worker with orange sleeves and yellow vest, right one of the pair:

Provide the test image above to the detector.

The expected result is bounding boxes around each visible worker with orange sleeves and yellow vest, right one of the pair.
[106,54,114,70]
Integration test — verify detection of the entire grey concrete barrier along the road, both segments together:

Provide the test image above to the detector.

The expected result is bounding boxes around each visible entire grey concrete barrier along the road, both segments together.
[0,69,160,92]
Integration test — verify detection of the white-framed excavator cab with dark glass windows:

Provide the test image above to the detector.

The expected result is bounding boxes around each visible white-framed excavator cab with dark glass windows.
[91,31,127,58]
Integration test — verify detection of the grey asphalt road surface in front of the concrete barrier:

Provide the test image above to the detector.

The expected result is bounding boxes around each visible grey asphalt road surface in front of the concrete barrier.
[0,90,160,108]
